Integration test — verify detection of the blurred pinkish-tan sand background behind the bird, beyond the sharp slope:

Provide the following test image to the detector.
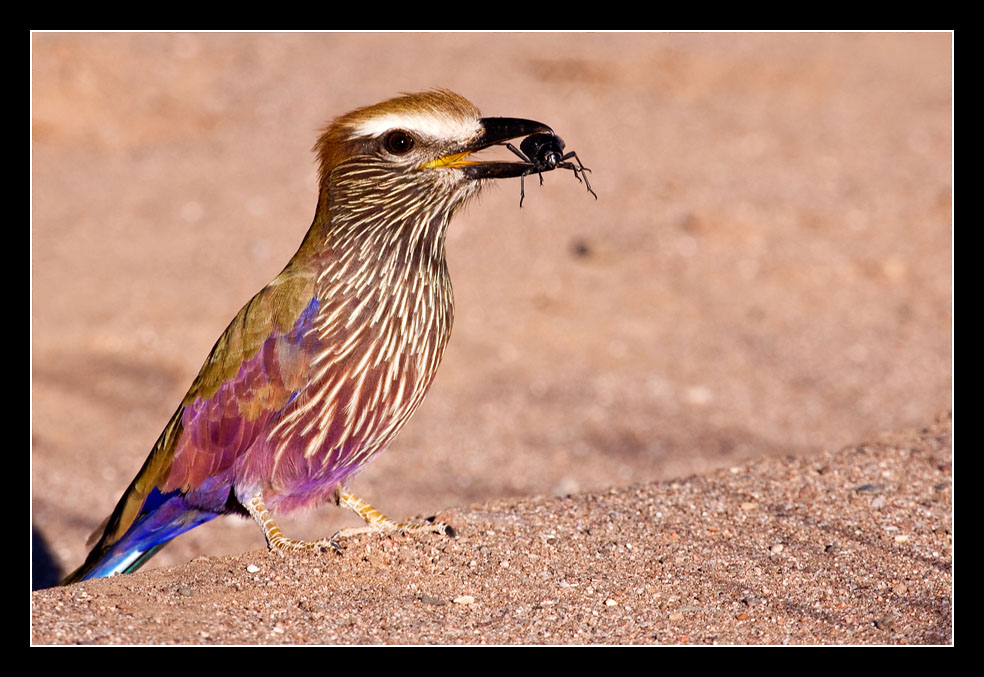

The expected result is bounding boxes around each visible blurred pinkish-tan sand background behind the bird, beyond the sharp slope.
[31,33,953,642]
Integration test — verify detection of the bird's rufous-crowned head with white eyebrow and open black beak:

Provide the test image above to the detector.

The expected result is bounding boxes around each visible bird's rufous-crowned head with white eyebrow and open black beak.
[315,89,552,222]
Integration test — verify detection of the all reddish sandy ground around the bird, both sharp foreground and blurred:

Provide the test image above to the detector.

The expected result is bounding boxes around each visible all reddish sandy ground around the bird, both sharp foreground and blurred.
[31,34,953,644]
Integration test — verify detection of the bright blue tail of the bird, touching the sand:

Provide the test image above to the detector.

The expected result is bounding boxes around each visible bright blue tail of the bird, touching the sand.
[60,490,219,585]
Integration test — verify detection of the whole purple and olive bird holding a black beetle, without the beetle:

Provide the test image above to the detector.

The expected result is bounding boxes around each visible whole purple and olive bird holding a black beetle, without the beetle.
[61,89,568,585]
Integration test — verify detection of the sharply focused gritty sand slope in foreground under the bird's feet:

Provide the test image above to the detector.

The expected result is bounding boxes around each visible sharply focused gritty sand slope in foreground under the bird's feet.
[32,417,953,644]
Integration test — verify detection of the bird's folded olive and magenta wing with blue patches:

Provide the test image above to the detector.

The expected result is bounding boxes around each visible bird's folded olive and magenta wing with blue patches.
[90,269,318,549]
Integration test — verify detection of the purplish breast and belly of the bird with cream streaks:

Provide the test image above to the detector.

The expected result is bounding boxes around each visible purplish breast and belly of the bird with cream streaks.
[236,157,466,512]
